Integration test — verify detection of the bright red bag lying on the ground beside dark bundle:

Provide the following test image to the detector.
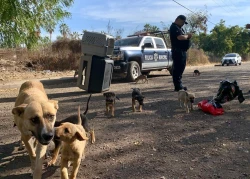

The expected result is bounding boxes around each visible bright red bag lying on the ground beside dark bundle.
[198,100,224,115]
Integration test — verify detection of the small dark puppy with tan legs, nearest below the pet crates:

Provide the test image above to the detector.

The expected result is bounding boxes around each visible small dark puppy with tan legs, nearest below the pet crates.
[103,92,120,117]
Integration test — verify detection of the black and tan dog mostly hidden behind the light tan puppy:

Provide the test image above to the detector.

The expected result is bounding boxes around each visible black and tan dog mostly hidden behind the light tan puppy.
[47,94,95,166]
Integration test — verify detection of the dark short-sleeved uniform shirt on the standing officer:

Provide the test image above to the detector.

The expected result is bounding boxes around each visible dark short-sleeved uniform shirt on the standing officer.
[170,23,190,51]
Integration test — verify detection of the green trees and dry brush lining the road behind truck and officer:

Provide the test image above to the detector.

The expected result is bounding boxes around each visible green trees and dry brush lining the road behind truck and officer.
[0,0,250,71]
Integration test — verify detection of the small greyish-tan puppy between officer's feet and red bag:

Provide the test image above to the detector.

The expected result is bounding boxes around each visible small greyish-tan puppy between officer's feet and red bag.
[178,91,195,113]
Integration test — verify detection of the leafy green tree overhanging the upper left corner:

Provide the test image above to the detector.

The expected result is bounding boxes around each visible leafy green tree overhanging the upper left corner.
[0,0,74,48]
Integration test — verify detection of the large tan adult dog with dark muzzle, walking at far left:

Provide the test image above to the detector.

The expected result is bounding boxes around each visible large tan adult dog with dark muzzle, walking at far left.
[12,81,58,179]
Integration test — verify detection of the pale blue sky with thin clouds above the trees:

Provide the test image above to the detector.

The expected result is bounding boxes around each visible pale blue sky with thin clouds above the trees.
[43,0,250,40]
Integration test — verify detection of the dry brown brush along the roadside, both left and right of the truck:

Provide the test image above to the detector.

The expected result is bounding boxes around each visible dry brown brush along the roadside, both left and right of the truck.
[0,43,249,71]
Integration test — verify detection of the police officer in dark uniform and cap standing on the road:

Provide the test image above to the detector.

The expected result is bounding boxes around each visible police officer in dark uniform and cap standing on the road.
[170,15,192,91]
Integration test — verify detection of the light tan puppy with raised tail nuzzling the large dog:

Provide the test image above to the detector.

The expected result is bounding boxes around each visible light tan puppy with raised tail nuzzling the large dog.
[55,107,88,179]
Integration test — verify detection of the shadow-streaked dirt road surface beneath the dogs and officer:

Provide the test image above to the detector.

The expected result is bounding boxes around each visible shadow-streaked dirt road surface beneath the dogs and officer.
[0,63,250,179]
